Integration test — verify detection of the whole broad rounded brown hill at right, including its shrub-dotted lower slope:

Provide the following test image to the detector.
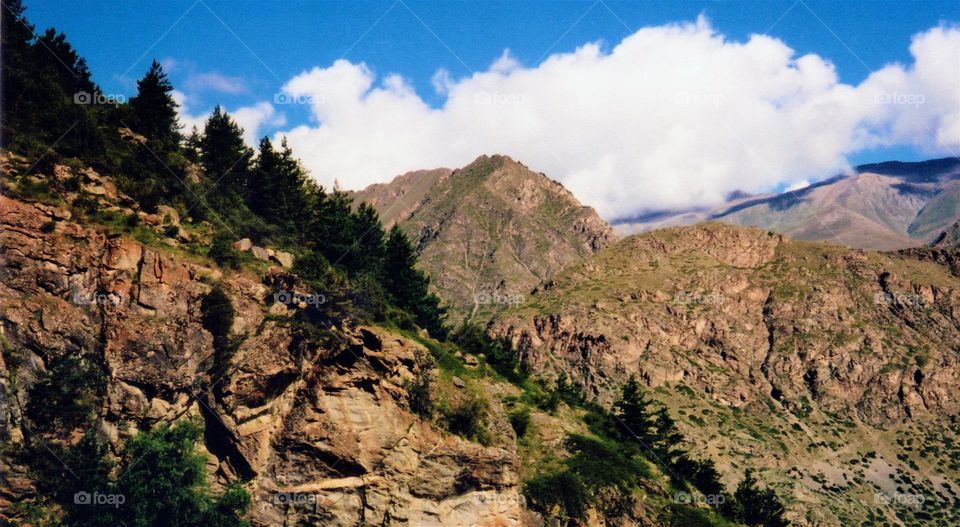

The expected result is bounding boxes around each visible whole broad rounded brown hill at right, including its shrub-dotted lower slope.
[490,222,960,525]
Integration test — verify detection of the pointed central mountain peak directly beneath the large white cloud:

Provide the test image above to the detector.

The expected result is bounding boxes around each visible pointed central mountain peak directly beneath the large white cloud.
[353,155,613,321]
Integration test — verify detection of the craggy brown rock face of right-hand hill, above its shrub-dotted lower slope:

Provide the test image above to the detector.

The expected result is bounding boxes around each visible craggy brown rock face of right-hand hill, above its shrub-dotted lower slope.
[492,224,960,425]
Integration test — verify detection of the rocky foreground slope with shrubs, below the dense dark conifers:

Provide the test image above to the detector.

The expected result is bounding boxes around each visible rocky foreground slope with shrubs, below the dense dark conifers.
[0,161,752,527]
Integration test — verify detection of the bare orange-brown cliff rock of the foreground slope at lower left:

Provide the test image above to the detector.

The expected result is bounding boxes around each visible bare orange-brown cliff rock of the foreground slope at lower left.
[0,196,522,526]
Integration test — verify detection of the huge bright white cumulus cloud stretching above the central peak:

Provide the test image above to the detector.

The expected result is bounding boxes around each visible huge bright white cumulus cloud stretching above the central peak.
[272,18,960,219]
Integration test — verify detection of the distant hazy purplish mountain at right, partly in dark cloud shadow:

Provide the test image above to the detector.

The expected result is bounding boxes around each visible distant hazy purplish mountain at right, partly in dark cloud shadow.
[618,158,960,250]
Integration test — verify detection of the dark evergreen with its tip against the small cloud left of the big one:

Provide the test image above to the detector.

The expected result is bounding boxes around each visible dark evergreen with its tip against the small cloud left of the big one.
[200,106,253,205]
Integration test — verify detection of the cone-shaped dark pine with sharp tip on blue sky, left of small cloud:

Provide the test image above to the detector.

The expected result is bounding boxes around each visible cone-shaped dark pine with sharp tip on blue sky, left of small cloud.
[130,61,180,150]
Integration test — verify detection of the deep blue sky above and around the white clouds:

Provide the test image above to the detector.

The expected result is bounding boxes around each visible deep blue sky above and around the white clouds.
[20,0,960,219]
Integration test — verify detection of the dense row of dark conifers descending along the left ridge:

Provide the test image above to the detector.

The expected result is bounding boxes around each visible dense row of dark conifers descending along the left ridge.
[0,0,445,338]
